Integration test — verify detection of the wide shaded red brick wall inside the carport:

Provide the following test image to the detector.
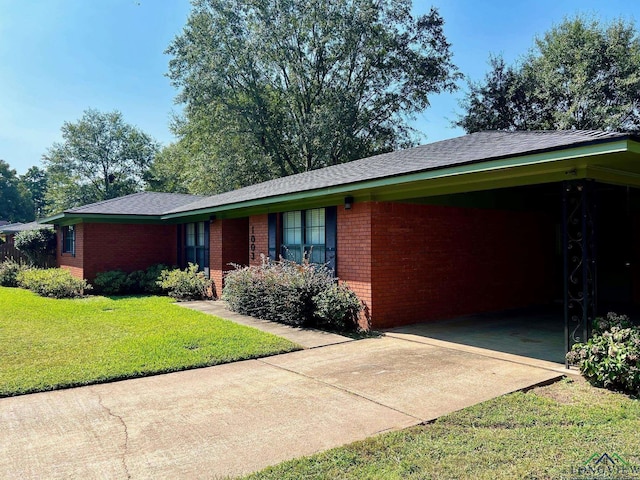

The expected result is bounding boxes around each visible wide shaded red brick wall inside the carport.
[370,203,555,328]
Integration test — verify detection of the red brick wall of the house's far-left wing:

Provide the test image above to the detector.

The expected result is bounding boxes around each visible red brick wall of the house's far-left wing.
[68,223,177,281]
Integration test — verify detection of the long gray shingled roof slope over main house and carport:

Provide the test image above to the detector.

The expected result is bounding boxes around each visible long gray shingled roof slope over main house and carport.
[165,130,630,214]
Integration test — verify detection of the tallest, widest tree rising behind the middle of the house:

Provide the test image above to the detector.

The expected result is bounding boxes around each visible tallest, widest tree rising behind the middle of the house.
[163,0,459,191]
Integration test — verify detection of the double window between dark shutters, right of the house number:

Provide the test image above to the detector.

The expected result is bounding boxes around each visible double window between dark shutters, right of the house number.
[282,208,326,263]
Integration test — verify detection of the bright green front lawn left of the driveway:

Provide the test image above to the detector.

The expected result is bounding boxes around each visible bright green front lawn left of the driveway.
[0,287,300,397]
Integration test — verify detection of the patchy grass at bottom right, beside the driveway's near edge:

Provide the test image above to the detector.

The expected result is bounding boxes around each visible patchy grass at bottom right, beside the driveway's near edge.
[246,379,640,480]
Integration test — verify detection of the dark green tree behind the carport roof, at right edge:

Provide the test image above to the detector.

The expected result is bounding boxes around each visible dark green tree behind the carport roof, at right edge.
[456,17,640,132]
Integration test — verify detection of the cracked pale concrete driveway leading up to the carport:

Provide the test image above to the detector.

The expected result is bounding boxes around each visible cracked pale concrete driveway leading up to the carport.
[0,336,561,479]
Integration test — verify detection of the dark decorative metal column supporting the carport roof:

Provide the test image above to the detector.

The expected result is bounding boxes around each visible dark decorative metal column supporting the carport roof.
[562,180,596,366]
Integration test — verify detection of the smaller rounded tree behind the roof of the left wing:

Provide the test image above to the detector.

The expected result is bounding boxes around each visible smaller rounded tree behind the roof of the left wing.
[43,109,158,212]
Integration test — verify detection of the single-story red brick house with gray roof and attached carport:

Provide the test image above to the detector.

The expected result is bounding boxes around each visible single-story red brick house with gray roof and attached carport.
[43,131,640,348]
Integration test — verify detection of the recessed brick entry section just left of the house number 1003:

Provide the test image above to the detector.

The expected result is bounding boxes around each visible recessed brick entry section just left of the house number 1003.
[209,218,249,296]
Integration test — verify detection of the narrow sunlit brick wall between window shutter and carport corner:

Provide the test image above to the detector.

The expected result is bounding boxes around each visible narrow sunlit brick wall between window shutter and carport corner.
[336,203,375,327]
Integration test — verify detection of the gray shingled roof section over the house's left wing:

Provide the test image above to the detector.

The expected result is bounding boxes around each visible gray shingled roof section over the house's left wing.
[64,192,206,216]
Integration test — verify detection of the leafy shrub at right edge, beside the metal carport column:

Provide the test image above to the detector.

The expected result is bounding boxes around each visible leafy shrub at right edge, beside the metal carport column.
[567,314,640,395]
